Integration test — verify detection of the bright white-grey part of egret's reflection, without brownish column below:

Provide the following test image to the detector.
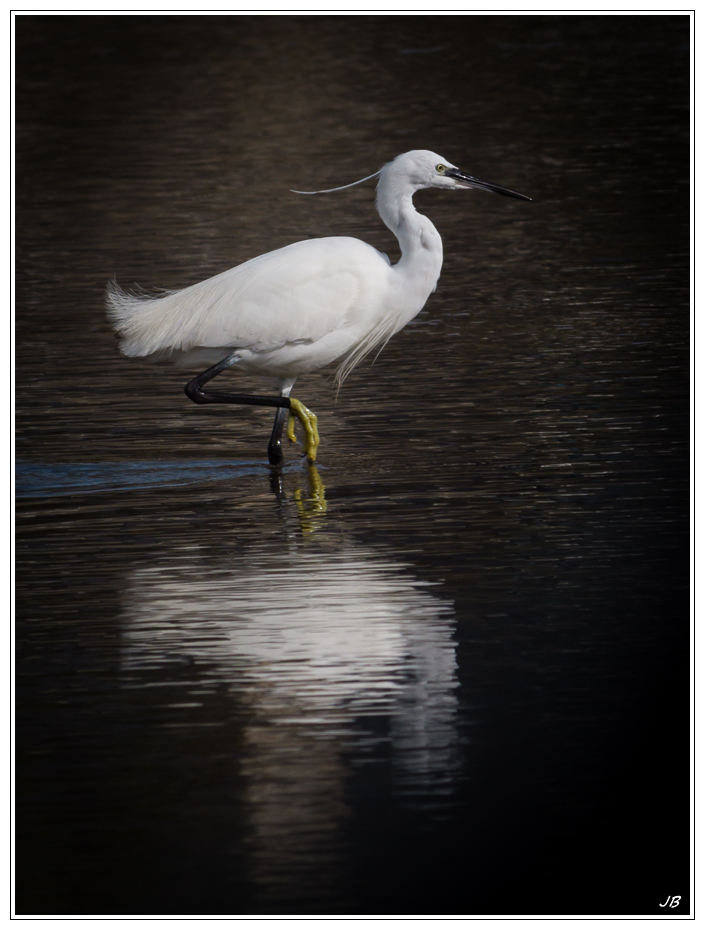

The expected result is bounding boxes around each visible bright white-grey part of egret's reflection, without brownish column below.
[123,547,457,748]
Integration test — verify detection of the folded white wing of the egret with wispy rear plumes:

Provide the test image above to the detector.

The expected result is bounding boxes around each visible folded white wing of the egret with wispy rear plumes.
[107,237,390,356]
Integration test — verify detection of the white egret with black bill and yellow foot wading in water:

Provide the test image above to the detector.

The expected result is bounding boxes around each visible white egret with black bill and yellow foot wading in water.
[107,151,531,464]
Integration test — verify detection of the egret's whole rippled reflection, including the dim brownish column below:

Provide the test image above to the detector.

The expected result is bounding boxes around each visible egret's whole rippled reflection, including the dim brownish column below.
[122,526,457,901]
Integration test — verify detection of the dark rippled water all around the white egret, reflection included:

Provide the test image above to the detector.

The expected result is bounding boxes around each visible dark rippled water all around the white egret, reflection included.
[16,16,690,915]
